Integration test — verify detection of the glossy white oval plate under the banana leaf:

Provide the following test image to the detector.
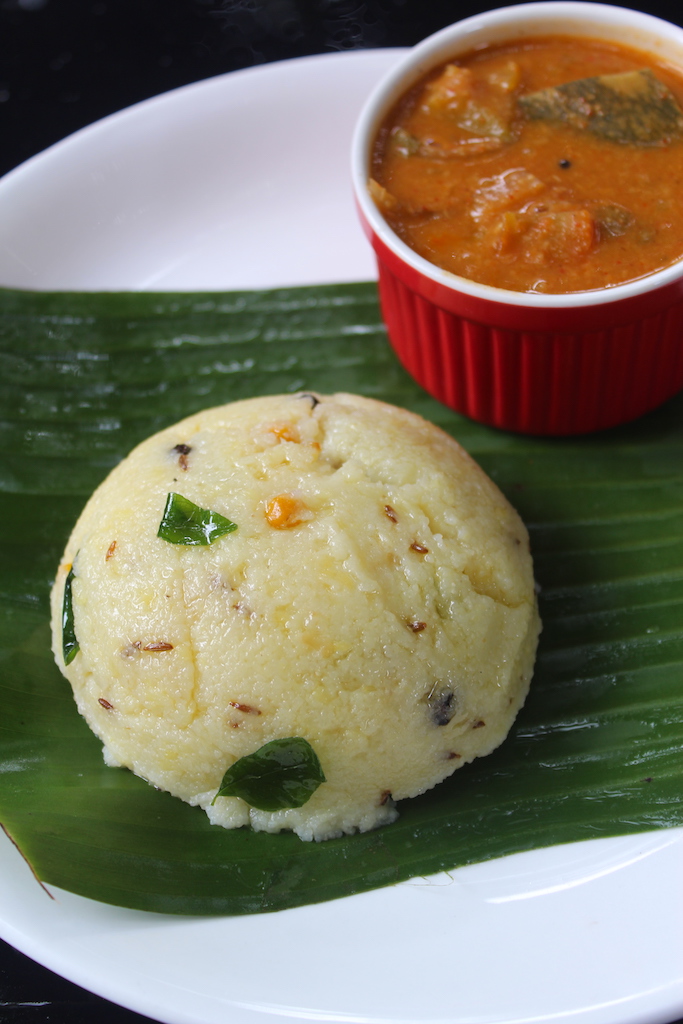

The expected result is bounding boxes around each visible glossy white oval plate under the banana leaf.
[0,50,683,1024]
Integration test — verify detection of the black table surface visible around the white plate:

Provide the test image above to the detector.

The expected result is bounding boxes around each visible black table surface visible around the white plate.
[0,0,683,1024]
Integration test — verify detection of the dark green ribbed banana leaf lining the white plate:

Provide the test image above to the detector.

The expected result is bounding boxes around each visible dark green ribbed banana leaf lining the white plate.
[0,283,683,914]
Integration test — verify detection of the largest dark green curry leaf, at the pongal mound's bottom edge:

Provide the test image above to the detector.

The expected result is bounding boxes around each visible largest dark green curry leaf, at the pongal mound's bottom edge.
[213,736,326,811]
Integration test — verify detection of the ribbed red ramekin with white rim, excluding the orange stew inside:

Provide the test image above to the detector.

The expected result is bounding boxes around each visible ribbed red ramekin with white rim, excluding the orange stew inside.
[351,0,683,435]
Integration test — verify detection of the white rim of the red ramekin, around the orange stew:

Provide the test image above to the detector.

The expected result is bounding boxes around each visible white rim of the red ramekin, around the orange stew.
[351,0,683,310]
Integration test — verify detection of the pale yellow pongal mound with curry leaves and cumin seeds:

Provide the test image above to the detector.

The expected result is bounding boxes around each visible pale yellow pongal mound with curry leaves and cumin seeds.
[52,394,540,840]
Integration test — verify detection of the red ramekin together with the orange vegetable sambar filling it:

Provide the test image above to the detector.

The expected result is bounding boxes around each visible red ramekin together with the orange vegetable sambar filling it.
[352,0,683,435]
